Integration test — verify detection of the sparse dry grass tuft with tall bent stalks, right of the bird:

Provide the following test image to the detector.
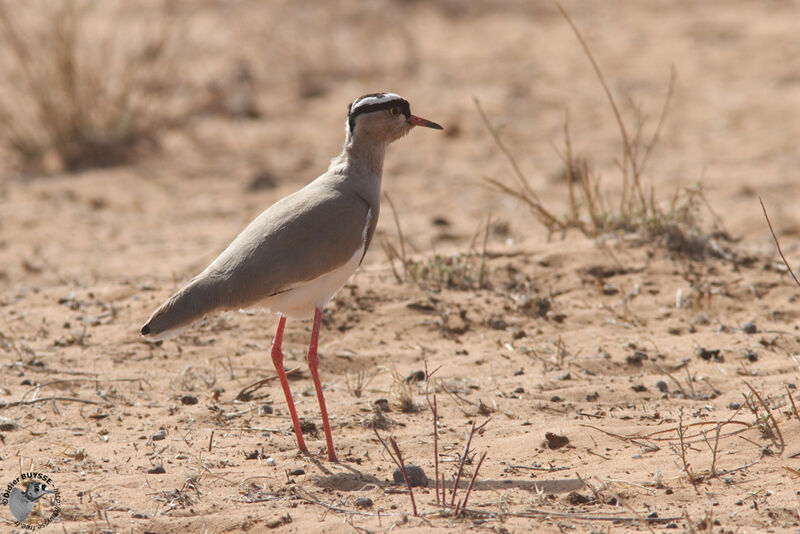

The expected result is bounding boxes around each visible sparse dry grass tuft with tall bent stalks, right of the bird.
[475,6,726,258]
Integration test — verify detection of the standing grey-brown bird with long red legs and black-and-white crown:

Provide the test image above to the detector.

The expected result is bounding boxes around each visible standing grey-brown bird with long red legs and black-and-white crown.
[141,92,443,462]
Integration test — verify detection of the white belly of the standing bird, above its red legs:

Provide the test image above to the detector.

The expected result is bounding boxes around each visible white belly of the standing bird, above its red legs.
[261,245,364,319]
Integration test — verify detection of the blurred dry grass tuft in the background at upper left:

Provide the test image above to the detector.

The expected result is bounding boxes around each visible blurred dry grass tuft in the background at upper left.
[0,0,181,172]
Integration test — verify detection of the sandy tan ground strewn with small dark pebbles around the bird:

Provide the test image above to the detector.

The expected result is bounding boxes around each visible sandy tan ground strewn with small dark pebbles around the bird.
[0,0,800,533]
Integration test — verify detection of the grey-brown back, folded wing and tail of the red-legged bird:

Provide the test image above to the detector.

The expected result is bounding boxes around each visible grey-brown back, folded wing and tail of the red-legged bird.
[142,173,380,337]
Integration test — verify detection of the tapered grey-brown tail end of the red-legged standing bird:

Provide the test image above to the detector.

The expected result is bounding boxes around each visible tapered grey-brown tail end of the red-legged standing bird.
[142,277,220,340]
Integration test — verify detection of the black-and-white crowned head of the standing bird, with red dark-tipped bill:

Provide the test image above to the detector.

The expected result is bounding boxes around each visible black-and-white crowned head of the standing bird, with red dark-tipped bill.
[347,93,443,144]
